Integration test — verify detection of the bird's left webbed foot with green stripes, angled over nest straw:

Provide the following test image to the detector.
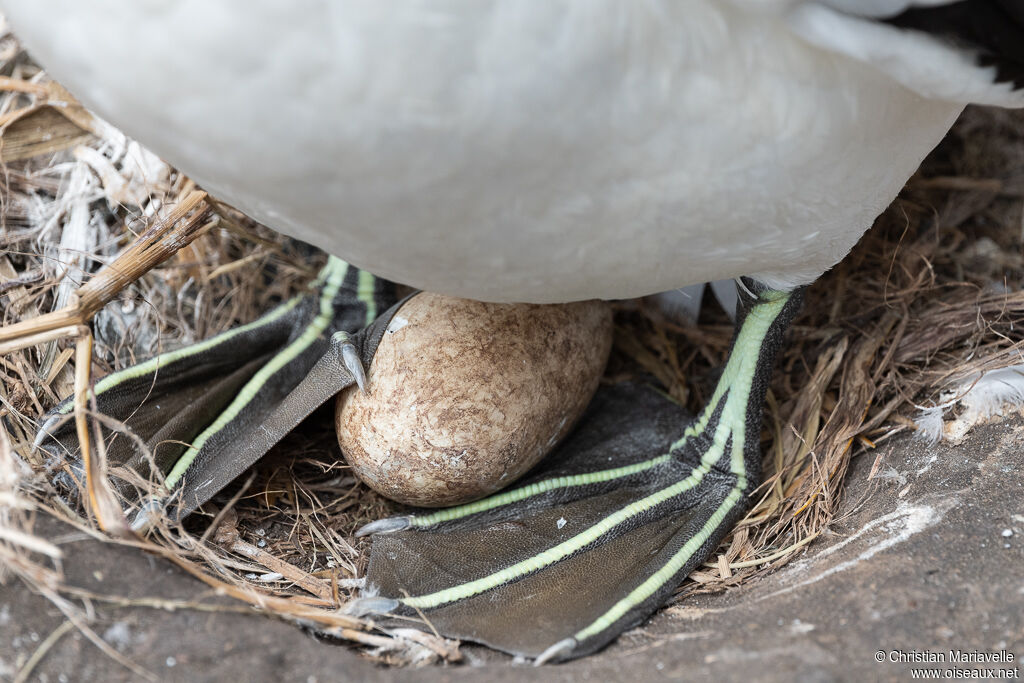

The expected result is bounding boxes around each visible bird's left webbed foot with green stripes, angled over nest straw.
[37,257,403,527]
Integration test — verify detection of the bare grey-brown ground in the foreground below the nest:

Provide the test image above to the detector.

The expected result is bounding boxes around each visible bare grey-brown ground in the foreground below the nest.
[0,417,1024,681]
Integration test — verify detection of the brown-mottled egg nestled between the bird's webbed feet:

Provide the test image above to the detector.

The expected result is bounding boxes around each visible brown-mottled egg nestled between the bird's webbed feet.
[335,293,612,507]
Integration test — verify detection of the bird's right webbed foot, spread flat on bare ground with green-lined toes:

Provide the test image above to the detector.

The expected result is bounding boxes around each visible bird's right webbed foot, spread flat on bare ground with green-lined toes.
[356,281,801,661]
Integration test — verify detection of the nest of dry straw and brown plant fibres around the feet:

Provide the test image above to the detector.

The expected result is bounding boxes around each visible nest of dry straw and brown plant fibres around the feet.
[0,24,1024,665]
